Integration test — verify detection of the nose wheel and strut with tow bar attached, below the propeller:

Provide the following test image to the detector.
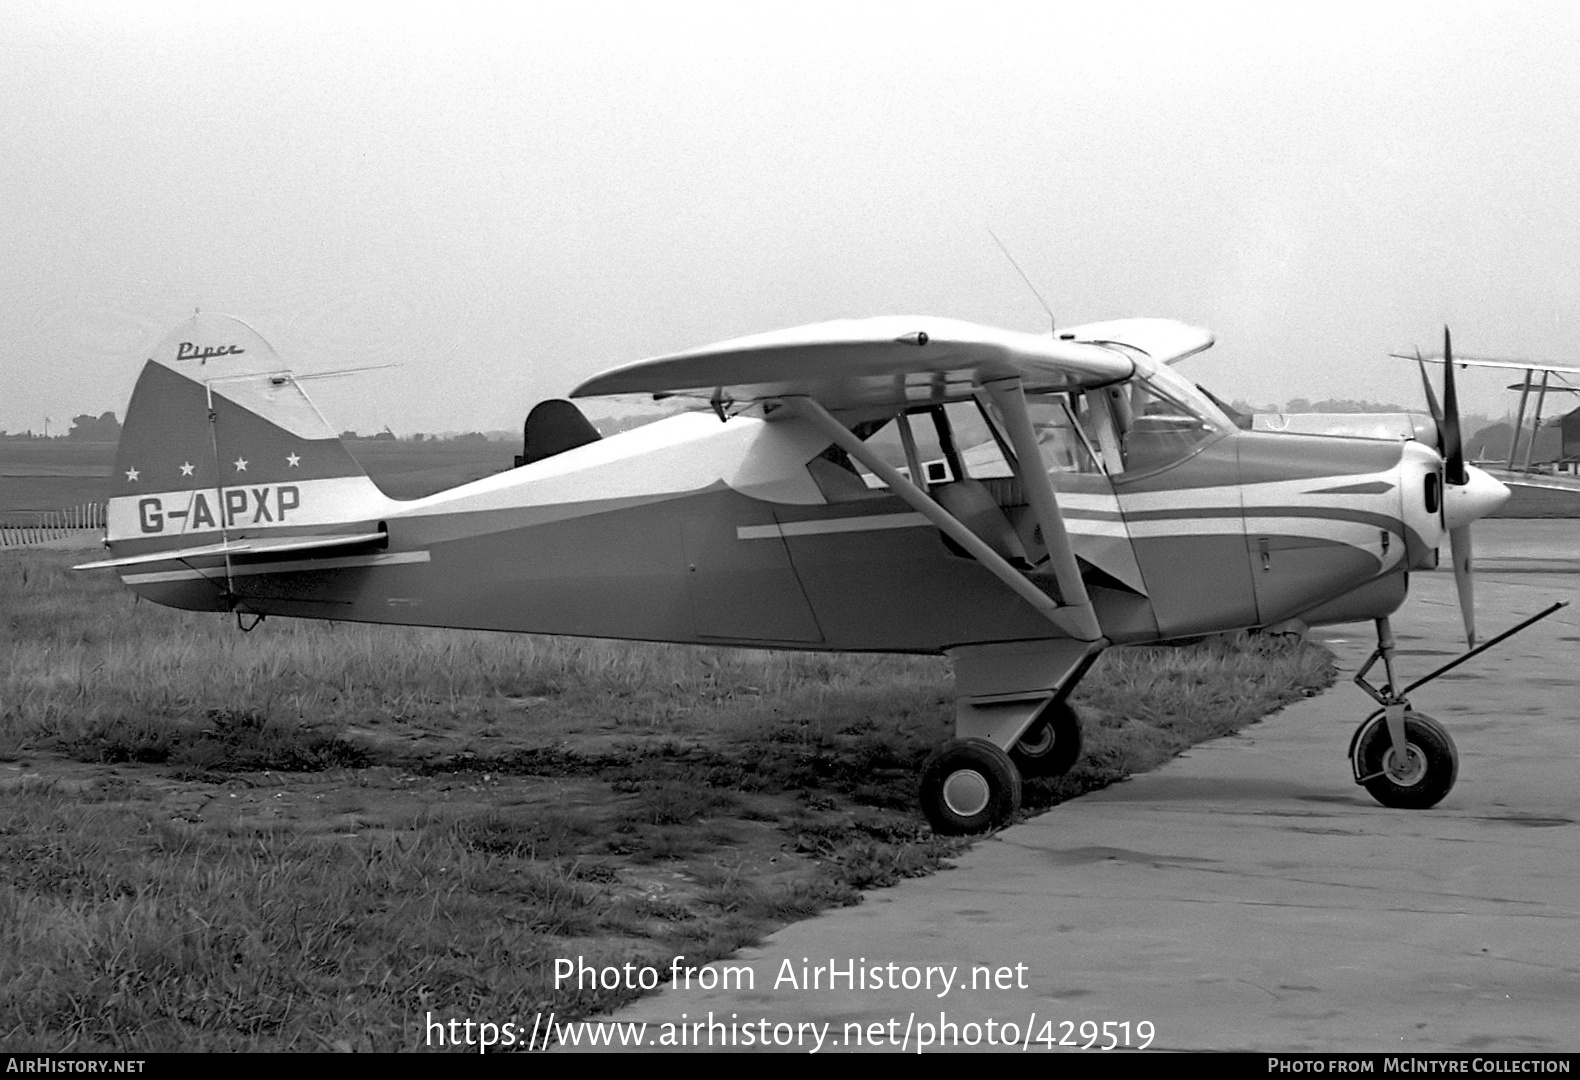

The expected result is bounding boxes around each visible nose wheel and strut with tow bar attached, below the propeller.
[1349,603,1564,810]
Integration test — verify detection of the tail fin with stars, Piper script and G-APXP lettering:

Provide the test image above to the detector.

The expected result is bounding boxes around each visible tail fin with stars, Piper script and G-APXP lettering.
[106,307,390,552]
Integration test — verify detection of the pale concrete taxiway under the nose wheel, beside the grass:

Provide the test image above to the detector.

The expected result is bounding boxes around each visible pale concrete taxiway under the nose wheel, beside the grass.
[581,521,1580,1052]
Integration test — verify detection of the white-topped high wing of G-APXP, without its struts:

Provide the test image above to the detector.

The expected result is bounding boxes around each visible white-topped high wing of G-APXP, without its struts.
[570,316,1212,411]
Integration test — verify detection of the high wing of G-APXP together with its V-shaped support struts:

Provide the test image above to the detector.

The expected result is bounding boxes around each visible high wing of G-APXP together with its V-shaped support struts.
[570,316,1212,649]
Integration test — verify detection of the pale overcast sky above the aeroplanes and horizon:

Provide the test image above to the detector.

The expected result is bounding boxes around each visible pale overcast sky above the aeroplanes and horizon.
[0,0,1580,434]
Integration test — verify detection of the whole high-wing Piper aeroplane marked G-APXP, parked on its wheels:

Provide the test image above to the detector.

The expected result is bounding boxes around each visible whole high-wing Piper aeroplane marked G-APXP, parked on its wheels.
[85,314,1561,832]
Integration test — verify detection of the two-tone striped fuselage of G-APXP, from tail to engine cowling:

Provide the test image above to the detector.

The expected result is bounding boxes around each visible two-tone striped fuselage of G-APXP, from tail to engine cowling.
[112,414,1436,652]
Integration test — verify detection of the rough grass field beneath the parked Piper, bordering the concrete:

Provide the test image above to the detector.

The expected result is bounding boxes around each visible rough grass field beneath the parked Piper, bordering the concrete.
[0,551,1332,1050]
